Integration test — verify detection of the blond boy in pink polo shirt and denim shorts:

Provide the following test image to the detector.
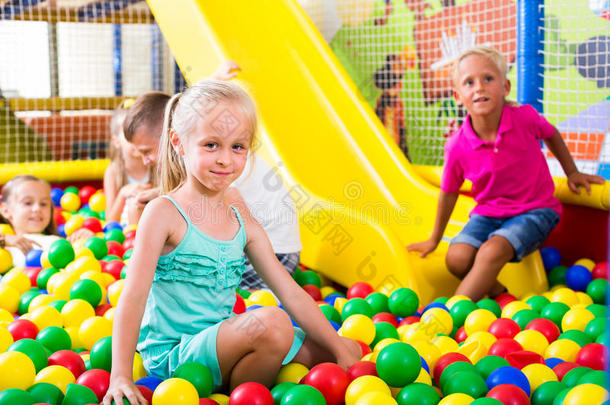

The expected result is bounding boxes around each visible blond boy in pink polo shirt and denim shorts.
[407,46,604,300]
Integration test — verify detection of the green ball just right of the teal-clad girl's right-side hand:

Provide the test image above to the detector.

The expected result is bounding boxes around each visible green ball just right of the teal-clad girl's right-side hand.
[377,342,421,387]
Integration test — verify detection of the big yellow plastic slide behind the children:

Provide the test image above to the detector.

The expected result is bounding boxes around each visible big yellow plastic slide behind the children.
[148,0,547,303]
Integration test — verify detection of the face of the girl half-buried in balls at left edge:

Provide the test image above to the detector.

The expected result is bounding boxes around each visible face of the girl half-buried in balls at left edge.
[2,181,51,235]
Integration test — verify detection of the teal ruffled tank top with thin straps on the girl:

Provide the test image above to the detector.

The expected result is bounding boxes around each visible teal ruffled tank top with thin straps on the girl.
[137,196,246,351]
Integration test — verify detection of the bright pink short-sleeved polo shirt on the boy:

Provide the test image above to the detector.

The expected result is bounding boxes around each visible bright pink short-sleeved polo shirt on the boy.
[441,105,561,218]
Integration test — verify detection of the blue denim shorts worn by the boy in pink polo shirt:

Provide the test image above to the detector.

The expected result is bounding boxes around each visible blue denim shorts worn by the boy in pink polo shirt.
[451,208,559,262]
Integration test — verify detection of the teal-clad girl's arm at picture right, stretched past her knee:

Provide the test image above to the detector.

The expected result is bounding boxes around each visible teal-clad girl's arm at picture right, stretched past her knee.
[233,193,360,368]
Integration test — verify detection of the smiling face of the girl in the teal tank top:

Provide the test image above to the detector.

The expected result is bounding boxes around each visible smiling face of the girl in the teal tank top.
[172,103,252,191]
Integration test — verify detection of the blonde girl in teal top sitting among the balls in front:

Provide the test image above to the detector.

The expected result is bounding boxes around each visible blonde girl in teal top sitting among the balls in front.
[103,80,361,405]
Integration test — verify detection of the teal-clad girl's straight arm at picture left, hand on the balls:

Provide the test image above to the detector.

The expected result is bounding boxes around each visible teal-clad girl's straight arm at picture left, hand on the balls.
[103,199,172,405]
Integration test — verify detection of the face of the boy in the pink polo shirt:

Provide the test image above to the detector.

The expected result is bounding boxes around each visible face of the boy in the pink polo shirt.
[454,55,510,116]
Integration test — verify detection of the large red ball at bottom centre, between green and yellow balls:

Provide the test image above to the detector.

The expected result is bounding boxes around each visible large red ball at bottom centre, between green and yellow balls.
[300,363,351,405]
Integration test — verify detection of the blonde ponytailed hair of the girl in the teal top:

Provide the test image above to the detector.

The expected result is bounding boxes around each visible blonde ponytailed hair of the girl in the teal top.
[157,80,257,193]
